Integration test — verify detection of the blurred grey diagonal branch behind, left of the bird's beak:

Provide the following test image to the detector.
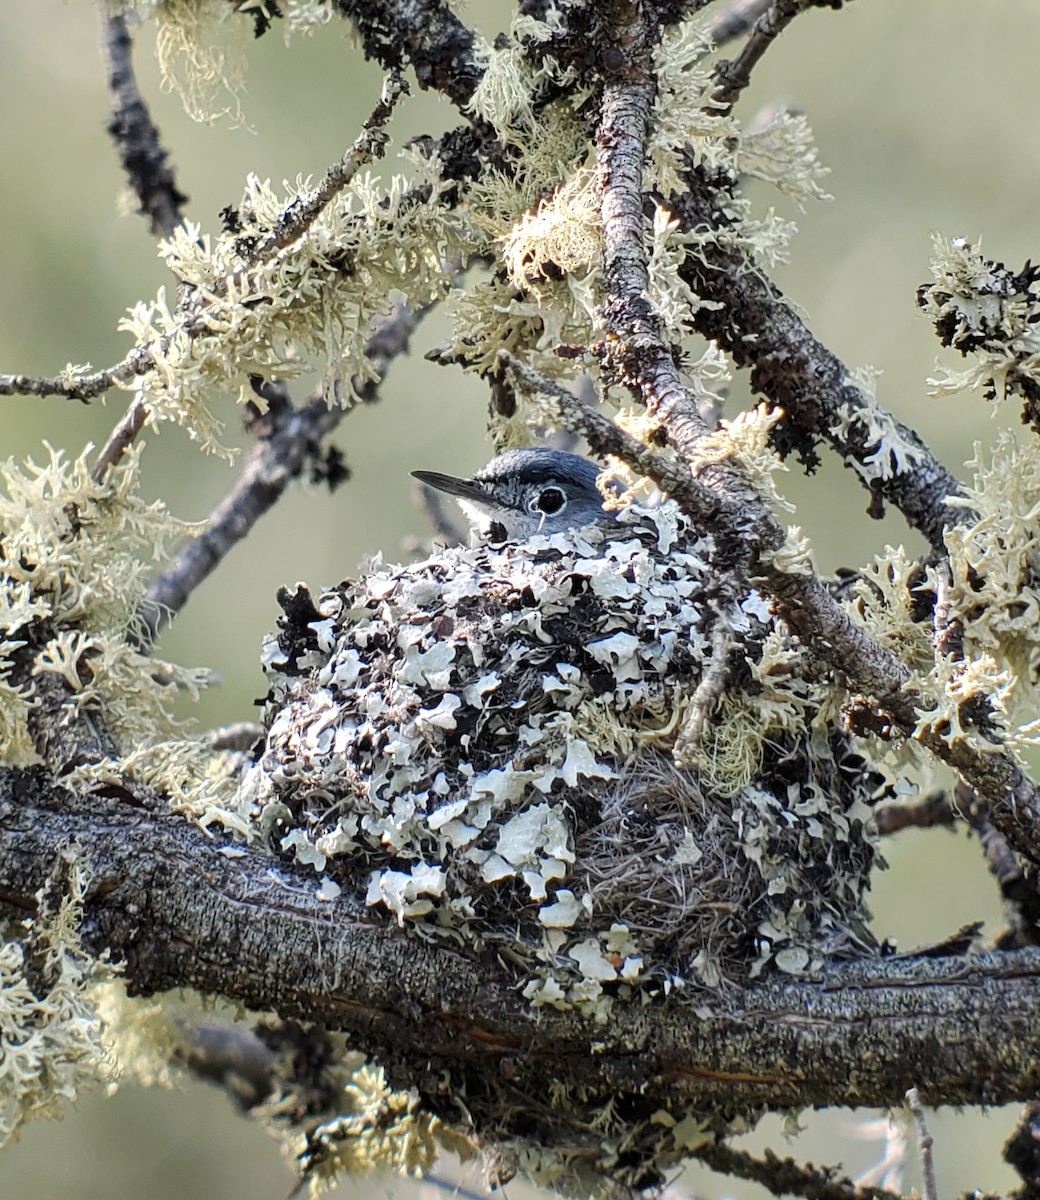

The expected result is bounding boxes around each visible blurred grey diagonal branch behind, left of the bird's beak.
[137,295,431,644]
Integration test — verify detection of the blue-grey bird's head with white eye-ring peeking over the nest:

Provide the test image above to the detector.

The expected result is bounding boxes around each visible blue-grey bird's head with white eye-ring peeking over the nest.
[411,446,614,542]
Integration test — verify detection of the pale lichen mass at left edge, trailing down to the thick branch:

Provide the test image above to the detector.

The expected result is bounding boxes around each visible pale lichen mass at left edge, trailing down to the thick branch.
[0,448,234,823]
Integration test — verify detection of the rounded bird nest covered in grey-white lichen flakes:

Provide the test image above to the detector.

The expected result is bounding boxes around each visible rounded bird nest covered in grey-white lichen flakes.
[241,504,877,1006]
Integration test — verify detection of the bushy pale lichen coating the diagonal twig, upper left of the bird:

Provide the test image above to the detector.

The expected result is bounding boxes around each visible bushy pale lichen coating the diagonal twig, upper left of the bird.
[121,152,468,449]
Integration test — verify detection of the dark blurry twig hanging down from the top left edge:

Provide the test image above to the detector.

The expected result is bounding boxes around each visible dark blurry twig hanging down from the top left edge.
[102,0,187,236]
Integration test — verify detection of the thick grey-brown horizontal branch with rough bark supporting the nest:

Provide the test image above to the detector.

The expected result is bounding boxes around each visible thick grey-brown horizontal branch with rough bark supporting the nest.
[0,772,1040,1112]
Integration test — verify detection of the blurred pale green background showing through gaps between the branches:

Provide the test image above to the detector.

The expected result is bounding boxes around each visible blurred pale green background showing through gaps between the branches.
[0,0,1040,1200]
